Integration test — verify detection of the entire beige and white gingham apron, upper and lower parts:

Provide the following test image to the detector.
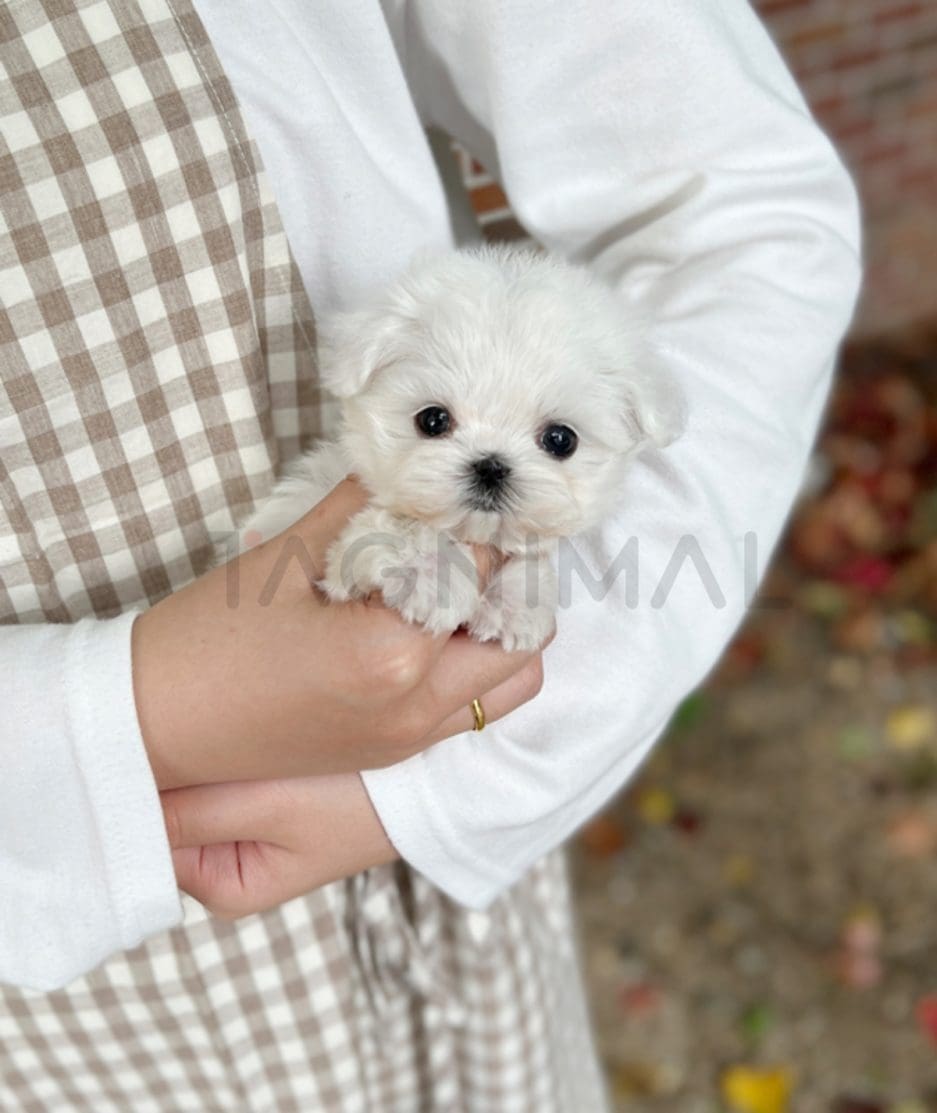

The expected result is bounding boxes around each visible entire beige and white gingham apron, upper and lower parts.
[0,0,604,1113]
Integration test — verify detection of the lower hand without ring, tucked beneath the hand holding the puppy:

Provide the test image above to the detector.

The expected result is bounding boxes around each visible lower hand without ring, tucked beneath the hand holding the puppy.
[160,774,397,919]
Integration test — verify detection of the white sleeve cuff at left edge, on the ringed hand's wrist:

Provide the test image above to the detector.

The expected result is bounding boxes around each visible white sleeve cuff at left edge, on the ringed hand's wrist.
[0,613,181,991]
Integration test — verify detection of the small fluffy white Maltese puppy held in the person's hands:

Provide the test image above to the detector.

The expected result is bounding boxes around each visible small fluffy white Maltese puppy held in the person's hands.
[235,247,682,649]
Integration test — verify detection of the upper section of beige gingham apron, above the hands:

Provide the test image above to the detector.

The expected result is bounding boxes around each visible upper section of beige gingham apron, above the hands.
[0,0,318,622]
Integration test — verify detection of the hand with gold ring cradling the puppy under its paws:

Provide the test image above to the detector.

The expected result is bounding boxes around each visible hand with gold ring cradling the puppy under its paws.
[132,480,542,789]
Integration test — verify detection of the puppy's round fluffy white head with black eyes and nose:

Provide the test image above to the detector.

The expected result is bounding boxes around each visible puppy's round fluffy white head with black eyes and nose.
[319,247,682,548]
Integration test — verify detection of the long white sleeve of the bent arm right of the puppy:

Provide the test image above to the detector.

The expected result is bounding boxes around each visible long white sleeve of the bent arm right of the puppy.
[364,0,860,906]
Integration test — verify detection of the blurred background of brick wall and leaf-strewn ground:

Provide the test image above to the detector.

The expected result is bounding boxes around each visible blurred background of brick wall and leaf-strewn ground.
[456,0,937,1113]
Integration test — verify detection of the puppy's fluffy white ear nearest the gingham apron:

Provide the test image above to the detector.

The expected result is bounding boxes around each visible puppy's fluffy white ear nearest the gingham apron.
[316,305,413,398]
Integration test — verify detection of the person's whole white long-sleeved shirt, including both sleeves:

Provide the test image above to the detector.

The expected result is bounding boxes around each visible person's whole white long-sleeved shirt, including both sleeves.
[0,0,859,988]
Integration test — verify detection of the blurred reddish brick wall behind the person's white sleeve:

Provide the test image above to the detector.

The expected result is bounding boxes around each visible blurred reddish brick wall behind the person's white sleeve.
[451,0,937,335]
